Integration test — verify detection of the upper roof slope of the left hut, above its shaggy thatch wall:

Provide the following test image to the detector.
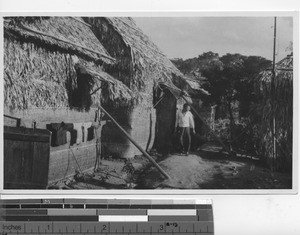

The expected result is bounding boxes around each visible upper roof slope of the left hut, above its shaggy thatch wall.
[4,17,115,63]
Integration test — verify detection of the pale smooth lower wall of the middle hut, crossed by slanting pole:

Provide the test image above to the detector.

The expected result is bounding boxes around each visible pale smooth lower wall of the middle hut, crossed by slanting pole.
[101,99,156,158]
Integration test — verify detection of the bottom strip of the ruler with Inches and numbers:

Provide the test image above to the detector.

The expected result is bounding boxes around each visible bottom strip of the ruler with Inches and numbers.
[0,218,214,235]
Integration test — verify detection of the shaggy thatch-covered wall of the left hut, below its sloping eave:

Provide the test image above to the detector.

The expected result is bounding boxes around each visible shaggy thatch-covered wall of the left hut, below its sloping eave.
[4,39,76,110]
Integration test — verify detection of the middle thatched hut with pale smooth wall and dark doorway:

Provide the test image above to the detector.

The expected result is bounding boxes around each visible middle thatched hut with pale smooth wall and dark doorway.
[84,17,204,158]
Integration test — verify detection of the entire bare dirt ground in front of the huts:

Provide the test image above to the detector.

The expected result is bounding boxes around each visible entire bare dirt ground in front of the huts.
[50,142,292,189]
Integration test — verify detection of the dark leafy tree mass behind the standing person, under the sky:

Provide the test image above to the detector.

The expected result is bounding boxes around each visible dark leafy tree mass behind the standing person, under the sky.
[173,52,271,117]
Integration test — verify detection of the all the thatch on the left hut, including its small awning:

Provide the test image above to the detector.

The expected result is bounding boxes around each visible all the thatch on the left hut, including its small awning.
[4,17,131,109]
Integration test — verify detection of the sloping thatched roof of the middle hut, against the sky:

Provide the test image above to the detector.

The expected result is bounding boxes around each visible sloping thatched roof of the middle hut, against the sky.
[106,17,203,91]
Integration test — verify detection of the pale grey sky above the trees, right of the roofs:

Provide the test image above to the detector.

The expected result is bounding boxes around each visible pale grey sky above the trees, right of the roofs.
[134,17,293,61]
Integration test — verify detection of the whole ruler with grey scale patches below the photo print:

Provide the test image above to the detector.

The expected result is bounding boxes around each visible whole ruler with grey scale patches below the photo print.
[0,199,214,235]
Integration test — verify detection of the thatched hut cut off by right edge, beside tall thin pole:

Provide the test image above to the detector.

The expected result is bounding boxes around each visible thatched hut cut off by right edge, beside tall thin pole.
[259,54,293,172]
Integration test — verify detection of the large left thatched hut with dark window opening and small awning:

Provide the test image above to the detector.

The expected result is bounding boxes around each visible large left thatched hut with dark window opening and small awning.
[4,17,131,185]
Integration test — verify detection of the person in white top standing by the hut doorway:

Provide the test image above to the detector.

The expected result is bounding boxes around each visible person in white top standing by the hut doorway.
[176,103,196,156]
